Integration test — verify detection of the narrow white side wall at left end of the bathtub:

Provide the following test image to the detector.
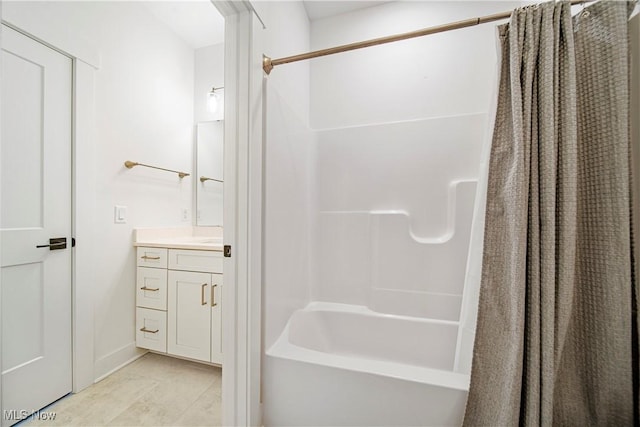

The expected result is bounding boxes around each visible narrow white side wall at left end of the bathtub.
[260,2,315,352]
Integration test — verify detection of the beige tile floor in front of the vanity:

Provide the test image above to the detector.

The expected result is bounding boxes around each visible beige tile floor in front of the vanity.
[20,353,222,427]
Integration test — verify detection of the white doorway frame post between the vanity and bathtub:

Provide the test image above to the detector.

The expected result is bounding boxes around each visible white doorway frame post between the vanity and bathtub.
[211,0,264,426]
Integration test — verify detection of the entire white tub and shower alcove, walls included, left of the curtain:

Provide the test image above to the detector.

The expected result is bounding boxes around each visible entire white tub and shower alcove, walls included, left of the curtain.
[262,1,521,426]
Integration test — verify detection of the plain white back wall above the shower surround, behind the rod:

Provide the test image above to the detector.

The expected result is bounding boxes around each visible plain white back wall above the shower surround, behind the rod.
[311,1,521,129]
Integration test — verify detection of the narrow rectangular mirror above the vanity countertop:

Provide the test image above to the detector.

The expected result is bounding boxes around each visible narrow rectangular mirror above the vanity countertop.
[194,120,224,226]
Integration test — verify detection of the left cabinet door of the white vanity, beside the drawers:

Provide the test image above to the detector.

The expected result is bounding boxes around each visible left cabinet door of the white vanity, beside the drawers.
[167,270,211,362]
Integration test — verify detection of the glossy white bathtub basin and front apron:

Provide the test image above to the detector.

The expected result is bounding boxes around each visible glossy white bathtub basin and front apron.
[263,302,469,426]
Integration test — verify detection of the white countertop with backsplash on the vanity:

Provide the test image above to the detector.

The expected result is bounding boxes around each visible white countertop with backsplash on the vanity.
[133,227,223,251]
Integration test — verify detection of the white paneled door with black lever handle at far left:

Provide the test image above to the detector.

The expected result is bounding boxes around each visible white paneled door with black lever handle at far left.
[0,25,72,425]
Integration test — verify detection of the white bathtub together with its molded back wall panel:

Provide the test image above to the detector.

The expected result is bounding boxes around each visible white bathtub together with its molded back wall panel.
[264,114,486,425]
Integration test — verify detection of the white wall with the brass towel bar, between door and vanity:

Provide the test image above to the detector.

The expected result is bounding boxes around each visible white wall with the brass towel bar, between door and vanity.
[3,2,194,378]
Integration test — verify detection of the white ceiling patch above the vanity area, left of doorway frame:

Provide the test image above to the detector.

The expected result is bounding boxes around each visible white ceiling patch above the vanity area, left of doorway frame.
[141,0,224,49]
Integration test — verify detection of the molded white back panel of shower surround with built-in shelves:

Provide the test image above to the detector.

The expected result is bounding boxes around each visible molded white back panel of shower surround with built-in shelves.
[312,115,486,320]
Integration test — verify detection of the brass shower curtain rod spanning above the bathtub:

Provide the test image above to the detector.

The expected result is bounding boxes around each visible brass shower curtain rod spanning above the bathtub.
[262,0,592,75]
